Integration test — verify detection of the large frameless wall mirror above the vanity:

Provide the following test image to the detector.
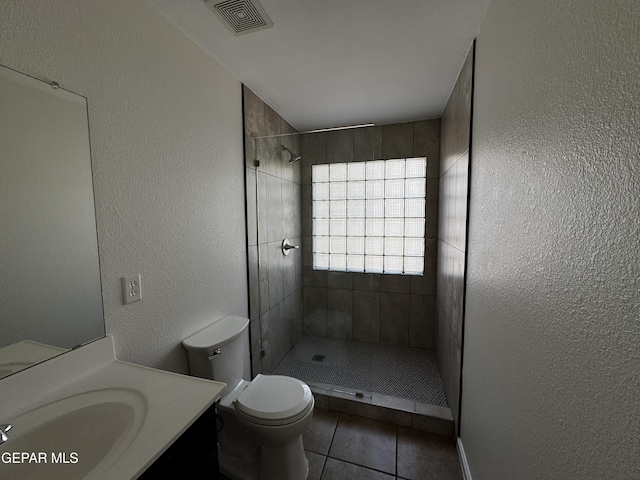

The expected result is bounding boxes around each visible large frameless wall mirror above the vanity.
[0,66,105,378]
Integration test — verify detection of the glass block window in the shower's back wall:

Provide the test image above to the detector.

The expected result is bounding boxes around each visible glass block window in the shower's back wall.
[311,157,427,275]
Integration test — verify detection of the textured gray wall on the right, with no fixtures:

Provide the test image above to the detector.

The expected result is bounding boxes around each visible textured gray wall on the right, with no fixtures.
[461,0,640,480]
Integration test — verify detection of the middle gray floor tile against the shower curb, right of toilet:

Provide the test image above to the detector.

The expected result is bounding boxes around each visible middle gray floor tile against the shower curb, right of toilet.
[325,414,396,478]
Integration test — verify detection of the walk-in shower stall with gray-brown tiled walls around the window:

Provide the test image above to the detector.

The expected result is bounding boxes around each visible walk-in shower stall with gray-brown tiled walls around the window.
[243,44,470,416]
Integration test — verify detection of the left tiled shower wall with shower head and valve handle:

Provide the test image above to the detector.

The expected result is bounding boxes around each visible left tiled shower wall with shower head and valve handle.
[243,86,303,374]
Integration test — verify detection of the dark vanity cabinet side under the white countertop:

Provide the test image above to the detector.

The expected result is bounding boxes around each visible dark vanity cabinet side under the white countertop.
[139,405,219,480]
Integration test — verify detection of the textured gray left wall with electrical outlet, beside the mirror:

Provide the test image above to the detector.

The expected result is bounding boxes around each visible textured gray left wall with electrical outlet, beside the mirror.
[0,0,248,373]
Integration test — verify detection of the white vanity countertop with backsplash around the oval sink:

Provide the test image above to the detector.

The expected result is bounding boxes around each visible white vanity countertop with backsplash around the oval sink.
[0,336,225,479]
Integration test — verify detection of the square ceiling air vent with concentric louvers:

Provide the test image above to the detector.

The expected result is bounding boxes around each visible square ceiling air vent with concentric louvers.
[204,0,273,35]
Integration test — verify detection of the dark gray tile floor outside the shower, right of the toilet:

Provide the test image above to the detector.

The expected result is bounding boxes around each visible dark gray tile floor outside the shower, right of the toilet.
[223,408,463,480]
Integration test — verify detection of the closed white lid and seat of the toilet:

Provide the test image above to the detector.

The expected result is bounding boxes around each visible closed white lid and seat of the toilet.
[235,374,314,426]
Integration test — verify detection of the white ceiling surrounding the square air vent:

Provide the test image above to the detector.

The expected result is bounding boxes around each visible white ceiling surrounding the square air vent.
[149,0,491,131]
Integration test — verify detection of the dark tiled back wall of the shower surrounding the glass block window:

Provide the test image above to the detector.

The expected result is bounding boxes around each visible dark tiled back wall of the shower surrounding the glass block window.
[300,120,440,348]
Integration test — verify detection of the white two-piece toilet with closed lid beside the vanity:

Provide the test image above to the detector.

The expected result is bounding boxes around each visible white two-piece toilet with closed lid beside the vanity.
[182,316,314,480]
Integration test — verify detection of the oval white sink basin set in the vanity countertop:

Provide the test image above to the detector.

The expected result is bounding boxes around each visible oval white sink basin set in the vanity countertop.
[0,388,147,480]
